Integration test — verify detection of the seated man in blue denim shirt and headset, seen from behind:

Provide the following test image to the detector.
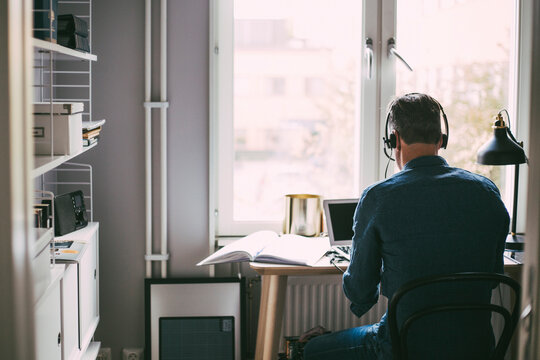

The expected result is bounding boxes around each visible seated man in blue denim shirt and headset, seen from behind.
[304,93,509,360]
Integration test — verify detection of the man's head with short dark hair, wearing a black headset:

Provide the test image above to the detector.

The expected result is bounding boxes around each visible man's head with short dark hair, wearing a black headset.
[388,93,448,169]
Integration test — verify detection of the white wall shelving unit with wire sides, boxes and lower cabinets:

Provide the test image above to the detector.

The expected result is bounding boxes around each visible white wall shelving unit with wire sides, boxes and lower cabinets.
[32,0,100,360]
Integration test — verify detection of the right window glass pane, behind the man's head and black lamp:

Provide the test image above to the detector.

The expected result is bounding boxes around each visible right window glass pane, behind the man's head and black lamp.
[396,0,515,197]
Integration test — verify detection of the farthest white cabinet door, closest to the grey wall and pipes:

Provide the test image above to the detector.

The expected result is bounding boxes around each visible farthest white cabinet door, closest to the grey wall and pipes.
[79,232,99,350]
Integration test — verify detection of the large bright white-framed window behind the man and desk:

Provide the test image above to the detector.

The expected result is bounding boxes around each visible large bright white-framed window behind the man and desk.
[211,0,516,236]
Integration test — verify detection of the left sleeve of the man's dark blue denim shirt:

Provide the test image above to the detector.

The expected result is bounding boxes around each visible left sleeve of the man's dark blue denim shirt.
[343,190,382,317]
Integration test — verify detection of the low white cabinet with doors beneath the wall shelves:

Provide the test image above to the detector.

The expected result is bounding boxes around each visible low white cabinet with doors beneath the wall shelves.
[35,222,99,360]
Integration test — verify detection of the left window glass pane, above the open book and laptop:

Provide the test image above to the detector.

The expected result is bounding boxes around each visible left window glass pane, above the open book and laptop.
[233,0,362,221]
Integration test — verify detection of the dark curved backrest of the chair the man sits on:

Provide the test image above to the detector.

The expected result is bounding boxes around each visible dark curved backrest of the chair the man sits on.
[388,272,521,360]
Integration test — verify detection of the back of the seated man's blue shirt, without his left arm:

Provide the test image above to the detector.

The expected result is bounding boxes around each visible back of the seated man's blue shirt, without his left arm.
[375,157,508,297]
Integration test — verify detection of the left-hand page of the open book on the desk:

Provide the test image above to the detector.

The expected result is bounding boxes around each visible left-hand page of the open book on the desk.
[197,230,278,266]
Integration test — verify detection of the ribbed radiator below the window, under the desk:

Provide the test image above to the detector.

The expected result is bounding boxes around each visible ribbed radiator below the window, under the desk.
[280,275,387,349]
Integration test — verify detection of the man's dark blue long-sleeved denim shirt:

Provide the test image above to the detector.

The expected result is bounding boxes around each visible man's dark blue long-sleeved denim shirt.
[343,156,509,317]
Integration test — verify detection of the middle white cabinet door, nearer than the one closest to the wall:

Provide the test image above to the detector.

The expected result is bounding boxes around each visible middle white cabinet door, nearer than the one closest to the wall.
[62,264,80,359]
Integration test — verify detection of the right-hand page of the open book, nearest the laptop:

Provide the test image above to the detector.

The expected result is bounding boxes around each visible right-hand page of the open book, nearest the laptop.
[255,234,330,266]
